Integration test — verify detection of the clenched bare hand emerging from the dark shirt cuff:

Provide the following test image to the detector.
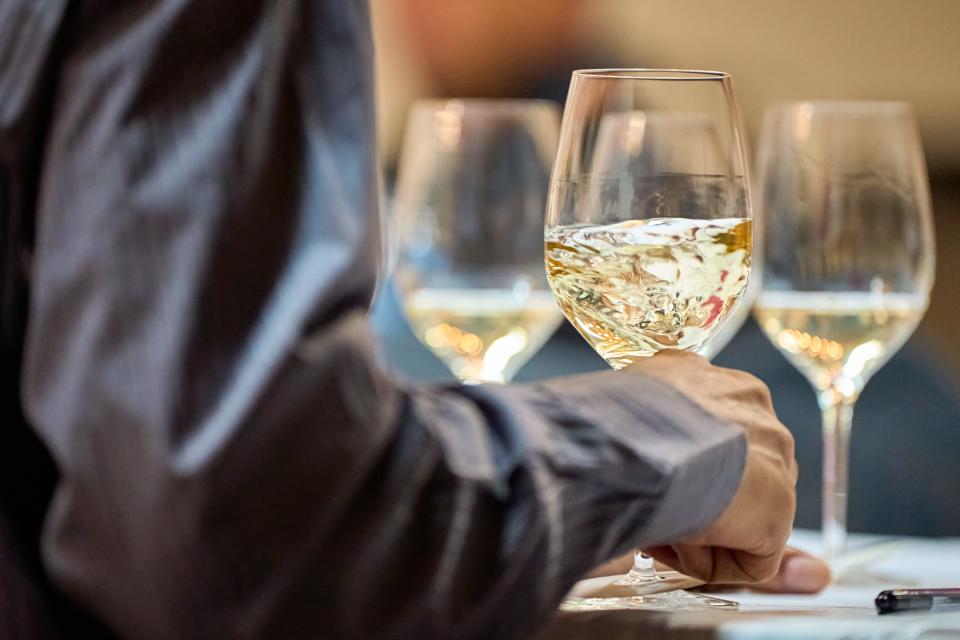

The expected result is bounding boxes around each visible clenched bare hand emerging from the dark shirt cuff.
[626,350,797,584]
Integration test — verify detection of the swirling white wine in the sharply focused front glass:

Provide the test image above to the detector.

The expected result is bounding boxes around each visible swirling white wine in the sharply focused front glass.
[546,218,752,369]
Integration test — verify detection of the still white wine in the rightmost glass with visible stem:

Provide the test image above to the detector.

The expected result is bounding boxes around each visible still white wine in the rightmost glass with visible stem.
[755,291,927,391]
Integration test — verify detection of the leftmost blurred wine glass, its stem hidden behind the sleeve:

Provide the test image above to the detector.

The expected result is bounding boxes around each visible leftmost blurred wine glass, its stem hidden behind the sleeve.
[394,100,562,384]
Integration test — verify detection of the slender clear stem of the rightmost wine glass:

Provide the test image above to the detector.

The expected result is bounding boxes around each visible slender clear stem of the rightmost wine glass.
[820,386,856,564]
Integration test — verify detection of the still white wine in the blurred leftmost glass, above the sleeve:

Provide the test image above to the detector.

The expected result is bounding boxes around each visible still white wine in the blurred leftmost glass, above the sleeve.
[404,289,562,383]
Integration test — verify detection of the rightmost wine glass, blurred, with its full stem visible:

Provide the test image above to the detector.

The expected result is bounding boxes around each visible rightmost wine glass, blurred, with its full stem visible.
[754,101,934,565]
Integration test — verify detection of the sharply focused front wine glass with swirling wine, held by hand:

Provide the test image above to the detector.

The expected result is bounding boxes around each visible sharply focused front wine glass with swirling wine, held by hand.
[545,69,752,608]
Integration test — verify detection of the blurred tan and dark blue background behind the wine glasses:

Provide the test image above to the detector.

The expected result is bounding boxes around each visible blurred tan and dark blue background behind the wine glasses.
[364,0,960,535]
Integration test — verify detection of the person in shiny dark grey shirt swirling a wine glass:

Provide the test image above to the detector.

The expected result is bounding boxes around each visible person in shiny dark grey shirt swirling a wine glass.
[0,0,824,640]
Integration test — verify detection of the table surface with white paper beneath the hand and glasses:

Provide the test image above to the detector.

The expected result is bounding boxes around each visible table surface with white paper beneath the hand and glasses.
[537,531,960,640]
